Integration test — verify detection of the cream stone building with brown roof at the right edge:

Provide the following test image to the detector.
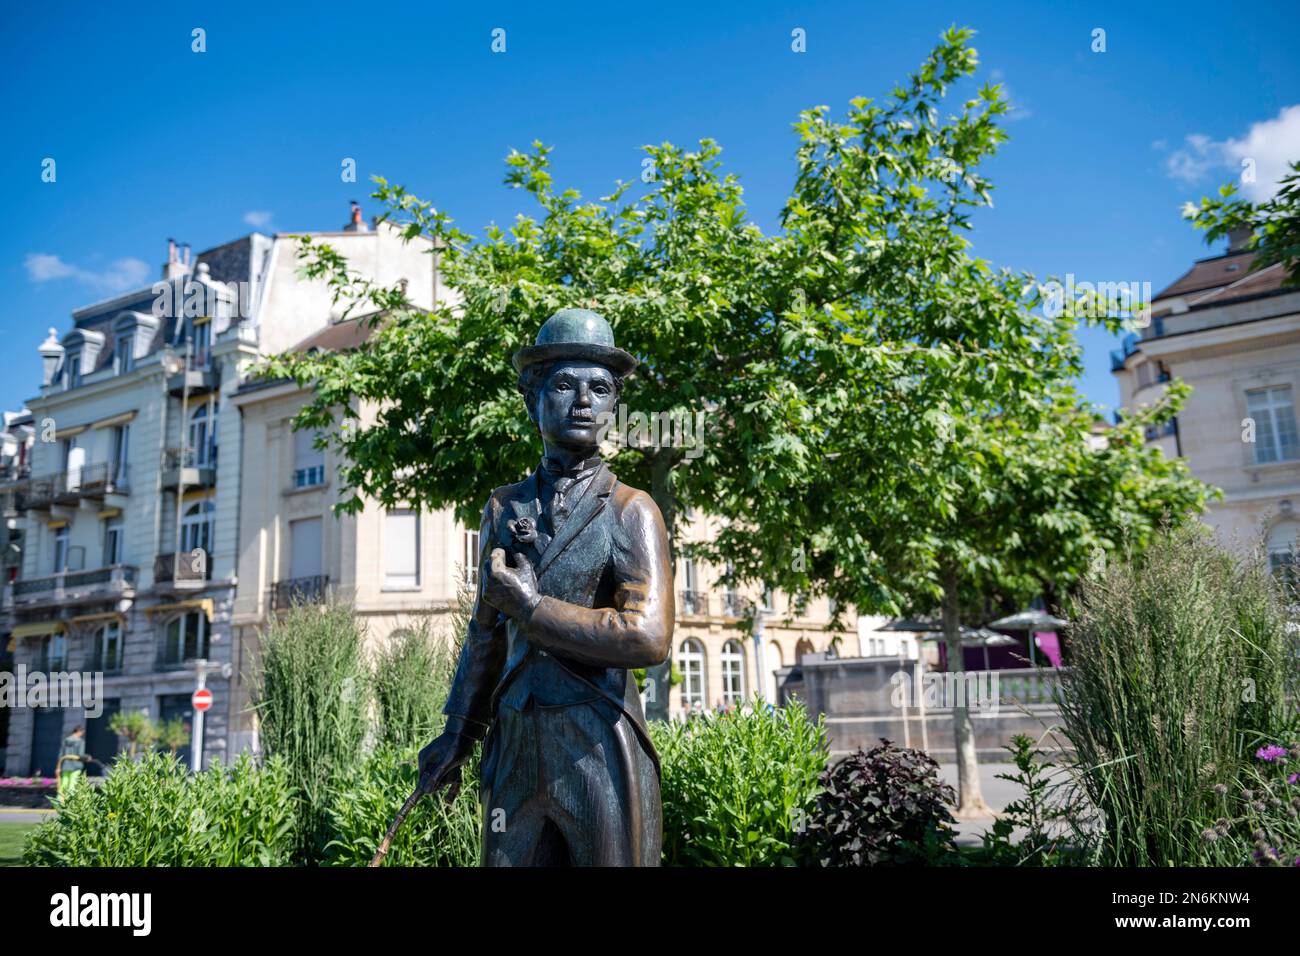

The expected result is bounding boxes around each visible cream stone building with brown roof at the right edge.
[1112,234,1300,567]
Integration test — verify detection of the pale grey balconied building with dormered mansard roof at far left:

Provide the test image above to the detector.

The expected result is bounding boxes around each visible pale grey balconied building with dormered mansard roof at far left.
[3,213,434,774]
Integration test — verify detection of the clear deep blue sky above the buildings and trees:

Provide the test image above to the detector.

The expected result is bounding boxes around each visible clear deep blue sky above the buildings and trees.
[0,0,1300,408]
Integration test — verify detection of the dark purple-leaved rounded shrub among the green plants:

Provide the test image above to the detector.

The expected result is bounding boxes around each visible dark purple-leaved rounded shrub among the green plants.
[803,740,956,866]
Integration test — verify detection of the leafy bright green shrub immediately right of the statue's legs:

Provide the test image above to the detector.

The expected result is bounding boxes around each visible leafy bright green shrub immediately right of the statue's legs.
[650,701,827,866]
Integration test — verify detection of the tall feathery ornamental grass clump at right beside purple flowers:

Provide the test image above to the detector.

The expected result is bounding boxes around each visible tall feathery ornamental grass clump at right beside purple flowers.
[1061,524,1296,866]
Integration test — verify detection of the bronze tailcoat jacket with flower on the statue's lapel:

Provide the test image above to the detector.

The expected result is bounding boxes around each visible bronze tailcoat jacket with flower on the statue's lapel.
[443,462,675,858]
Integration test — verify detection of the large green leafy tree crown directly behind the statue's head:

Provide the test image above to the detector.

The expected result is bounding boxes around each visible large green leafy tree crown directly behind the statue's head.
[265,29,1034,567]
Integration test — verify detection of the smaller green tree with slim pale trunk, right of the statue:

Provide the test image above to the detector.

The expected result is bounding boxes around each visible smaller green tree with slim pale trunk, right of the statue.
[842,381,1212,817]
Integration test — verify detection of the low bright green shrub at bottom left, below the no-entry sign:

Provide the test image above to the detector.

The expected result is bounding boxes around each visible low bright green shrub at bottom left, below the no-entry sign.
[23,753,296,866]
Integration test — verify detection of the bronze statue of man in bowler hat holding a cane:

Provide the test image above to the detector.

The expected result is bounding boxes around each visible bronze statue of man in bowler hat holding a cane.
[420,308,675,866]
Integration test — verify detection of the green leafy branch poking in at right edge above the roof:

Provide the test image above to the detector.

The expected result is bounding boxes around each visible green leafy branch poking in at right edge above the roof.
[1183,160,1300,285]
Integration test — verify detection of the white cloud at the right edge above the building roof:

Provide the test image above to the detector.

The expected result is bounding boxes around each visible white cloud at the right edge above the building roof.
[1166,104,1300,203]
